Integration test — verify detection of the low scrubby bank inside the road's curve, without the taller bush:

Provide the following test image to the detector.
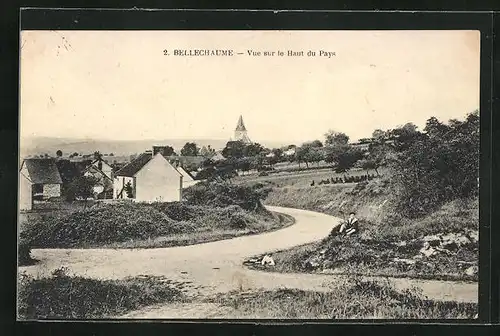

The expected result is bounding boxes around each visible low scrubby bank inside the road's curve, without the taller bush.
[21,202,277,248]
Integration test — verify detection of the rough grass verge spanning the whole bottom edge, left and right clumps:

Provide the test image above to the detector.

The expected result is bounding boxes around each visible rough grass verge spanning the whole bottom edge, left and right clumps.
[18,268,478,320]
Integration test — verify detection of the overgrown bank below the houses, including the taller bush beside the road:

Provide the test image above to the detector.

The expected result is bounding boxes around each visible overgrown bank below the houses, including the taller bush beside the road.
[19,182,282,256]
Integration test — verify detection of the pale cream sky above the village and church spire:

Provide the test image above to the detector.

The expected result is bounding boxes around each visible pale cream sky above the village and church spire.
[20,31,480,143]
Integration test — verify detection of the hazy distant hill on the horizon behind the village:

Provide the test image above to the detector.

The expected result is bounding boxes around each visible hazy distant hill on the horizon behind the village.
[20,137,287,157]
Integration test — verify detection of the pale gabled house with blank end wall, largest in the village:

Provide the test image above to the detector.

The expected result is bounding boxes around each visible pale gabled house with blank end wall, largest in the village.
[113,151,183,202]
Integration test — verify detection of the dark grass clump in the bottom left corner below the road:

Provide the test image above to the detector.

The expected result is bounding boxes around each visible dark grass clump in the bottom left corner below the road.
[18,269,185,319]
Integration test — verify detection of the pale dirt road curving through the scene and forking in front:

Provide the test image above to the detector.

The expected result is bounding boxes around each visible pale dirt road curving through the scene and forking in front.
[19,207,478,318]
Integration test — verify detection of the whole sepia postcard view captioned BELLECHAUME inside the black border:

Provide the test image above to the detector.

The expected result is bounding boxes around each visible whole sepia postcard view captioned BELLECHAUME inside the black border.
[17,30,480,321]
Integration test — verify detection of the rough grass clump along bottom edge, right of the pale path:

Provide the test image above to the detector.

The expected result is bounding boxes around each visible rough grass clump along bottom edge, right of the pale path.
[215,278,478,319]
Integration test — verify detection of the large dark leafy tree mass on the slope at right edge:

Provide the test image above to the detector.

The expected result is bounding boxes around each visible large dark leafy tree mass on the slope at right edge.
[392,111,480,217]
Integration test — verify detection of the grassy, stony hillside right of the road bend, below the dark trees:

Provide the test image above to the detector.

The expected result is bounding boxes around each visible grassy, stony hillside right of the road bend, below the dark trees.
[255,179,479,280]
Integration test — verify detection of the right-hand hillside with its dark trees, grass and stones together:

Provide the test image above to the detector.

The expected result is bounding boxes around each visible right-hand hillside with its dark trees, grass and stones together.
[260,111,479,280]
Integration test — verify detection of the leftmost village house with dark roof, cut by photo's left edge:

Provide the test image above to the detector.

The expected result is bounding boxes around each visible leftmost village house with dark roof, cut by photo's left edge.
[19,158,62,210]
